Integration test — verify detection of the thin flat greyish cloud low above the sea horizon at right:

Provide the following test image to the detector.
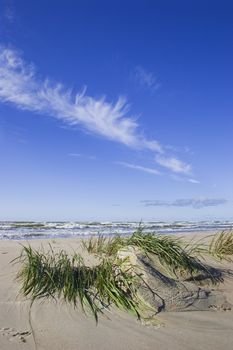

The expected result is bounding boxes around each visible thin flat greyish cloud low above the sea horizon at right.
[141,198,227,209]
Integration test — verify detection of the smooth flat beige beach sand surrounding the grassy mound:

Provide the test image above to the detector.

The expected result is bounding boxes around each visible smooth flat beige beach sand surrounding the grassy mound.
[0,232,233,350]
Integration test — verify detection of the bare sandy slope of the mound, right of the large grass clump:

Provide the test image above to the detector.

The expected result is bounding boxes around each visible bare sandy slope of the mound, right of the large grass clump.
[118,247,232,313]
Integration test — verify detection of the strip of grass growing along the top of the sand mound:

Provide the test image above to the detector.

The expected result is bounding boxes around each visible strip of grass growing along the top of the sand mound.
[83,227,211,276]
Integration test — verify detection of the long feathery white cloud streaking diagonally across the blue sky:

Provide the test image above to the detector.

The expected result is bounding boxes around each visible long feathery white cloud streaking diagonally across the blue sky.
[0,46,193,178]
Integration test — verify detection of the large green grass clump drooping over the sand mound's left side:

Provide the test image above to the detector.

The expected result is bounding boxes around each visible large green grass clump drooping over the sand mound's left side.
[17,246,144,321]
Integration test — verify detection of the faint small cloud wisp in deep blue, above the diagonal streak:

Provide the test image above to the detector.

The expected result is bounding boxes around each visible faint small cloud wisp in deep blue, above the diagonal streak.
[134,66,161,92]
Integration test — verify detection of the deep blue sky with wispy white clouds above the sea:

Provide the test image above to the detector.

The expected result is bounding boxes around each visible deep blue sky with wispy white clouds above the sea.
[0,0,233,221]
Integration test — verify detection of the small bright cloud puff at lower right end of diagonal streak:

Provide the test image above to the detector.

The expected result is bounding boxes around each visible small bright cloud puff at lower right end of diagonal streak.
[155,155,192,175]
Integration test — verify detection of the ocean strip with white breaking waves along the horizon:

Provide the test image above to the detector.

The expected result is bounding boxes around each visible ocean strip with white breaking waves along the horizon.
[0,221,233,240]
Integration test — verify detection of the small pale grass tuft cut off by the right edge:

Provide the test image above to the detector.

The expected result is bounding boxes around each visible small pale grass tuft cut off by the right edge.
[209,231,233,262]
